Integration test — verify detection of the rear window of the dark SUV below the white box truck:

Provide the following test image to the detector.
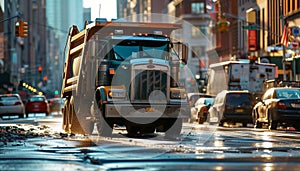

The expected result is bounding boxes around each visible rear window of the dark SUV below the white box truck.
[226,93,251,106]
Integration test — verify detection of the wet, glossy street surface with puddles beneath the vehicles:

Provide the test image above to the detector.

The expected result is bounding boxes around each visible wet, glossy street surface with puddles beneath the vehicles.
[0,117,300,170]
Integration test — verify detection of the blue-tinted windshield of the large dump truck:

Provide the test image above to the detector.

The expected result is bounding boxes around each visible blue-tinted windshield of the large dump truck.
[112,40,169,60]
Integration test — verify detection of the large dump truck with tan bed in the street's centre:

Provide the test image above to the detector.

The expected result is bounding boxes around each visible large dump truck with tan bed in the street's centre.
[61,19,190,137]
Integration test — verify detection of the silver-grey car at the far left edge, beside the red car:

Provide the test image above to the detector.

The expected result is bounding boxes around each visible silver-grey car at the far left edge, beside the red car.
[0,94,24,119]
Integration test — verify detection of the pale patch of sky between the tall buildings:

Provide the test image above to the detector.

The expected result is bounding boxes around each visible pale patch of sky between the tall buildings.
[83,0,117,20]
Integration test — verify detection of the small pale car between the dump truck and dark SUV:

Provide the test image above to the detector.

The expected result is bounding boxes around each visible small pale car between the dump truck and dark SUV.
[191,96,215,124]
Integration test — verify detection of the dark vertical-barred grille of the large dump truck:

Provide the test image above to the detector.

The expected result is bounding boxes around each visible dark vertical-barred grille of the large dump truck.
[131,69,168,101]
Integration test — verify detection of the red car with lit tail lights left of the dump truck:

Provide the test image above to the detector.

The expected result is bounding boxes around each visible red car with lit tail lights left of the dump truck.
[25,95,50,117]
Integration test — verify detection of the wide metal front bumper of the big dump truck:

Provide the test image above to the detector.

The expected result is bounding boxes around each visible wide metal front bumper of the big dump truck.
[105,103,191,118]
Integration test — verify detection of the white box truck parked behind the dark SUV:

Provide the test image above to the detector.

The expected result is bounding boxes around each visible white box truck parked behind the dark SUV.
[206,60,278,97]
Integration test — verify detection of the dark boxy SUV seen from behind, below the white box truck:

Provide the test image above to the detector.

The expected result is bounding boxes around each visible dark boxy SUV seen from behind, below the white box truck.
[208,90,253,127]
